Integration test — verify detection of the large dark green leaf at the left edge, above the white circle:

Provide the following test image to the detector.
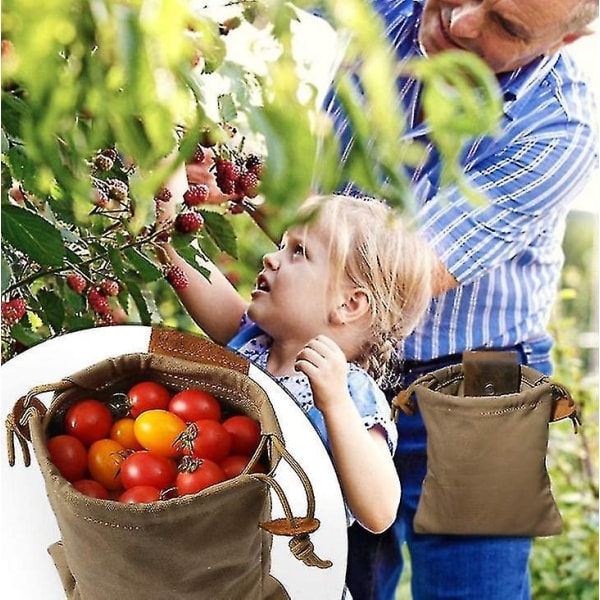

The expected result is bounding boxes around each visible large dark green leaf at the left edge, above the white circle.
[2,206,65,267]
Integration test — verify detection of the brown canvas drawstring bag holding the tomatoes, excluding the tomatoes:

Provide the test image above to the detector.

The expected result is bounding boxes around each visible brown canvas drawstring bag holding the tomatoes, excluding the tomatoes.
[7,329,331,600]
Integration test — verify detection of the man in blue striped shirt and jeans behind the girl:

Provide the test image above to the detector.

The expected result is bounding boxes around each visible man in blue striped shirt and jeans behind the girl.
[327,0,598,600]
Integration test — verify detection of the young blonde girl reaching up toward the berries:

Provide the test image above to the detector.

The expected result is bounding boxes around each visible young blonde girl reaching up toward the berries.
[159,163,433,532]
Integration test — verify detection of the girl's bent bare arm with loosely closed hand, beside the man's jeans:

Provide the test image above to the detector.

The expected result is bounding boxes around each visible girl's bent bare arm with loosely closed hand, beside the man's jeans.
[296,336,400,533]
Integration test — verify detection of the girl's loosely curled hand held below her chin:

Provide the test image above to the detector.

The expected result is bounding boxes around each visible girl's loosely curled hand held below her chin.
[295,335,348,412]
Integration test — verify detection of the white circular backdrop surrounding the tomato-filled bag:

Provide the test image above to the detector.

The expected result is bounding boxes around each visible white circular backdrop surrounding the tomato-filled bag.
[0,325,347,600]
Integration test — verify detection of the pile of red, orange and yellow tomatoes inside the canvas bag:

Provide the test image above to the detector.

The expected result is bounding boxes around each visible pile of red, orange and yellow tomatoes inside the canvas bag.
[47,380,264,503]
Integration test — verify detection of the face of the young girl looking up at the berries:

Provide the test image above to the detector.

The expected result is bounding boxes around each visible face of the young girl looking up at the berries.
[248,225,340,344]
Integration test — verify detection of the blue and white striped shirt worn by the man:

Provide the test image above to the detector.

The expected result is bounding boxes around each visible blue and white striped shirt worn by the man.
[326,0,597,360]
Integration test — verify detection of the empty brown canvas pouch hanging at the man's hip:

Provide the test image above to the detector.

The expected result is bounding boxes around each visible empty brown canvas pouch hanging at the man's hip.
[393,351,579,537]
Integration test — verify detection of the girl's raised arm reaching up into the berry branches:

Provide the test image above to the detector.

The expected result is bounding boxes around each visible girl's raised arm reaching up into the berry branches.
[158,166,248,345]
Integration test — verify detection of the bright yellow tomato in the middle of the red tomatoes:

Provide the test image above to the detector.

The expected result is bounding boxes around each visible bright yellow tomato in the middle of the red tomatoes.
[133,409,186,458]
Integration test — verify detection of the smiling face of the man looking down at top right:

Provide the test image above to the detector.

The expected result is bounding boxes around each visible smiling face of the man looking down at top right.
[419,0,577,73]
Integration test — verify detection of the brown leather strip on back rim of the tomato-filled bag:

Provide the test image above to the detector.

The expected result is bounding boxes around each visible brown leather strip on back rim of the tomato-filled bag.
[148,327,250,375]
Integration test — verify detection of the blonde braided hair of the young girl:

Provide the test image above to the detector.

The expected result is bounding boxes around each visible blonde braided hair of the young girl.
[300,195,435,382]
